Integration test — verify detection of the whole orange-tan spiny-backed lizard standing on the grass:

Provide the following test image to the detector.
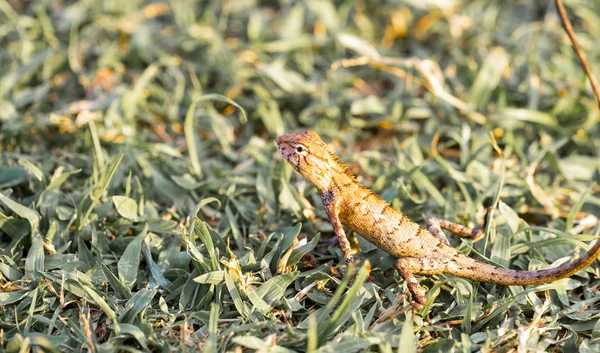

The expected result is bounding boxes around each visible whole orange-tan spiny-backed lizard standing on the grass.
[276,130,600,307]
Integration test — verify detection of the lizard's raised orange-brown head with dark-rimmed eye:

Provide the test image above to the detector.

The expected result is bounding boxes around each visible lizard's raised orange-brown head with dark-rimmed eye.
[275,130,338,191]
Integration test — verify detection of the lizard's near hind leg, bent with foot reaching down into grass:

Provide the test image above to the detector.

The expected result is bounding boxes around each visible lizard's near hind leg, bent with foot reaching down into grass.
[396,257,445,310]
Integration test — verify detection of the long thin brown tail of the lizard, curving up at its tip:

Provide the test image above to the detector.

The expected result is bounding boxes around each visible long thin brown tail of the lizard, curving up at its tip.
[448,240,600,286]
